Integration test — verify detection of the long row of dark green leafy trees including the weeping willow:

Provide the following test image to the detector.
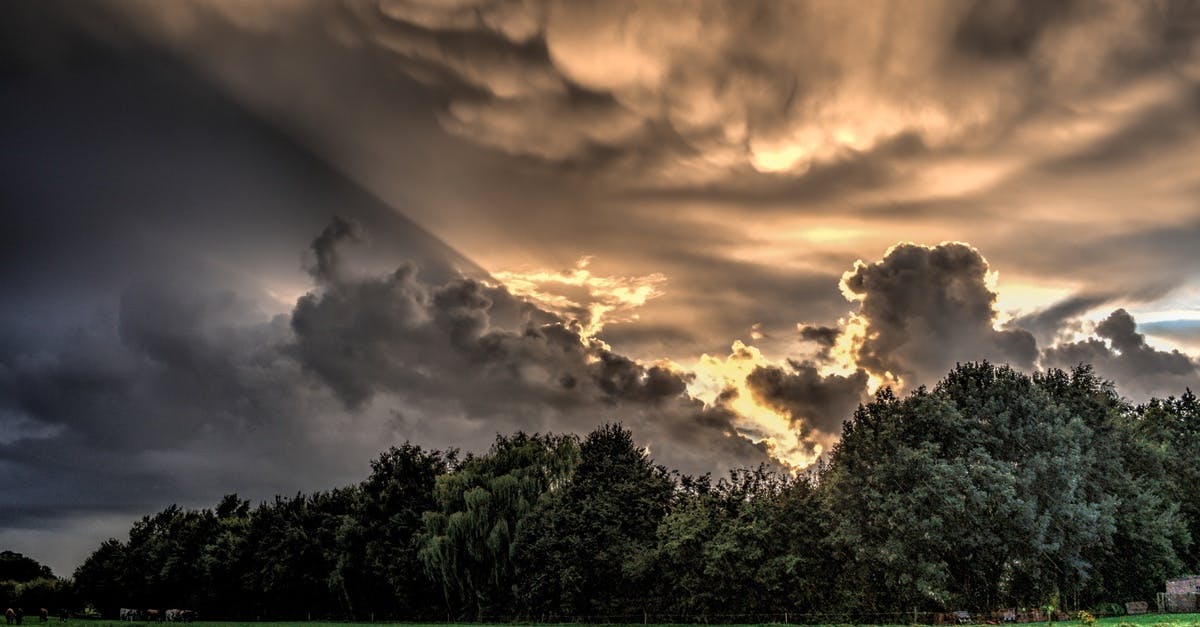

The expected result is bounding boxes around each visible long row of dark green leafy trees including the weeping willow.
[60,363,1200,622]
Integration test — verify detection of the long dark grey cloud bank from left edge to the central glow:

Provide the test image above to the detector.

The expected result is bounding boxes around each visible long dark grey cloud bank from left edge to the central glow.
[0,213,769,569]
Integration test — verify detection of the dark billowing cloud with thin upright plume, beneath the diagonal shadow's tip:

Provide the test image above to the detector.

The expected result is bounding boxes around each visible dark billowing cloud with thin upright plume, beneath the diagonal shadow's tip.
[288,221,764,471]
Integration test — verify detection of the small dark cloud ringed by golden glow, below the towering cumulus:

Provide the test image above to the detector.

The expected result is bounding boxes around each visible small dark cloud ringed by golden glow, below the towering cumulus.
[746,360,868,435]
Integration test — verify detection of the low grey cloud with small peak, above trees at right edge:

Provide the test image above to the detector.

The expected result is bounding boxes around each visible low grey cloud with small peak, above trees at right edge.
[1042,309,1200,400]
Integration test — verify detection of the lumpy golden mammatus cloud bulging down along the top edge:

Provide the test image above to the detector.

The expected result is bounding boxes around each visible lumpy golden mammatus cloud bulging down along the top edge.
[338,0,1195,185]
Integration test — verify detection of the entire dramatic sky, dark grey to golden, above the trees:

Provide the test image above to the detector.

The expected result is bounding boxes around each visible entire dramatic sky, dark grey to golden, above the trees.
[0,0,1200,574]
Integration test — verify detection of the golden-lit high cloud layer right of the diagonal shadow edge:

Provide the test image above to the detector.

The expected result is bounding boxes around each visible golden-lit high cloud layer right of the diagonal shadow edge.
[68,0,1200,365]
